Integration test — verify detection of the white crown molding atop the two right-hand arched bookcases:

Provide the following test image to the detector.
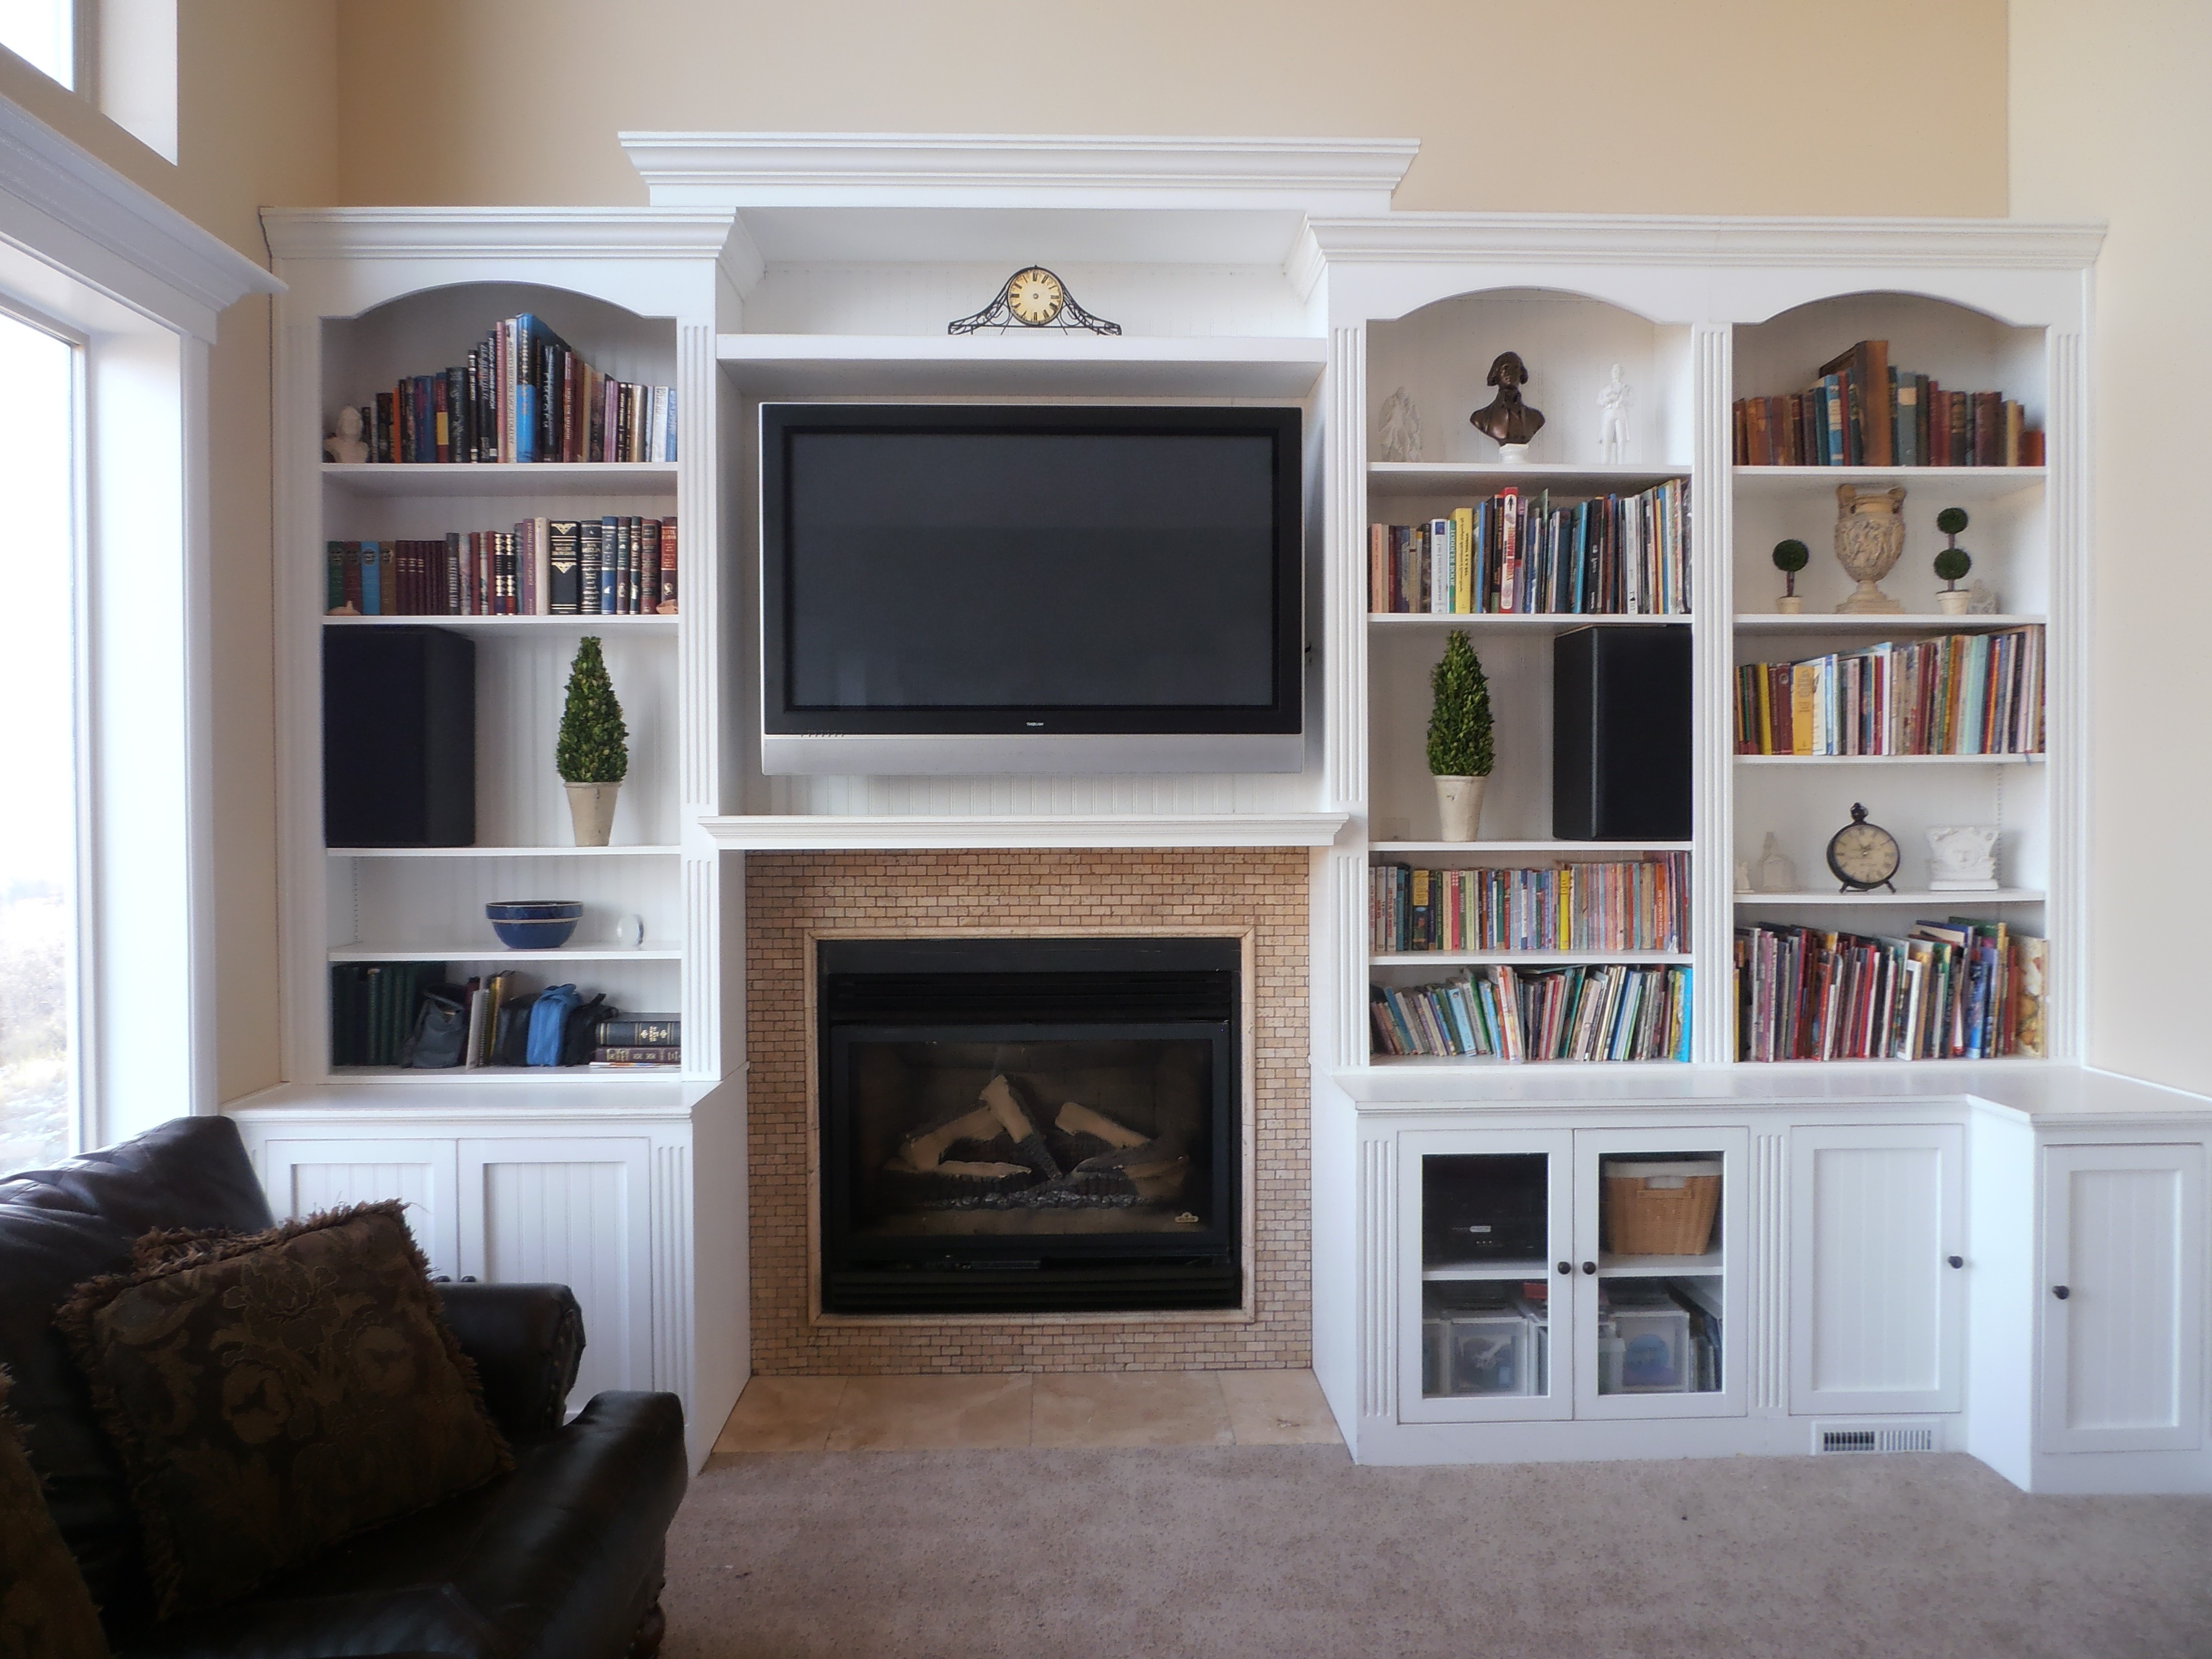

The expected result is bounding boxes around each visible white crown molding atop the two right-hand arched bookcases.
[1309,213,2104,270]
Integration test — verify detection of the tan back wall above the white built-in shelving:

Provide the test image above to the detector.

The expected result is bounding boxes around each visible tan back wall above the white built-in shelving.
[338,0,2004,215]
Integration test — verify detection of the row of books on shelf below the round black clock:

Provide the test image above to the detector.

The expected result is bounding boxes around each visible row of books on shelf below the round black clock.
[1736,916,2051,1060]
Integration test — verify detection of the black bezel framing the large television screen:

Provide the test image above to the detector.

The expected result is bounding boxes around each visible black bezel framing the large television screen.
[761,402,1305,747]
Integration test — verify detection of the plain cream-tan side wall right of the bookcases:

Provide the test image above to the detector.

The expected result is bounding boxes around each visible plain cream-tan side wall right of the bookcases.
[2011,0,2212,1106]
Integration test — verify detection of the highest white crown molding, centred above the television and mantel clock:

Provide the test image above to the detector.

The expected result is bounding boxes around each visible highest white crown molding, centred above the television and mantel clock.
[620,133,1420,213]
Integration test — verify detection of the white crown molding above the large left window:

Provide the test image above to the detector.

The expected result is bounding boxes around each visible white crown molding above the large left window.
[0,97,283,340]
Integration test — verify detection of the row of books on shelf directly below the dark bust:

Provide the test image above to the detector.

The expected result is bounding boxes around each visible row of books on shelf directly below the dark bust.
[1367,478,1690,617]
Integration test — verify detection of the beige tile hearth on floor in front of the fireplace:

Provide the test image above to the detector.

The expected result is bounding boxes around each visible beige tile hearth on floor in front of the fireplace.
[714,1372,1338,1456]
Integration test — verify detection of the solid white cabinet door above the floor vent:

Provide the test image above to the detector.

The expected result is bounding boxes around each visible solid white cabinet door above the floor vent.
[1790,1124,1966,1413]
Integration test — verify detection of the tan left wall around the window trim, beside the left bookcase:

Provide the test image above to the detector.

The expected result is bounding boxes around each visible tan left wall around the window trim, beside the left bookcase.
[0,13,338,1099]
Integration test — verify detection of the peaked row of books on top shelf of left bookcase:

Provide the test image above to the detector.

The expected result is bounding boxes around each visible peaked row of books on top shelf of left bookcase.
[361,312,677,462]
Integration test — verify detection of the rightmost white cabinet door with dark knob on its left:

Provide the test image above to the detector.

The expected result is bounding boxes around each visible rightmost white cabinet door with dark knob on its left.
[2037,1146,2205,1451]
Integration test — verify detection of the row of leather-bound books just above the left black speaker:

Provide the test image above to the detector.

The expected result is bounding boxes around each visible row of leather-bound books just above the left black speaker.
[325,513,677,617]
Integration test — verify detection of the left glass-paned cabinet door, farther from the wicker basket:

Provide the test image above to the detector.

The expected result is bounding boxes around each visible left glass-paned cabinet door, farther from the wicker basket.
[1398,1130,1573,1422]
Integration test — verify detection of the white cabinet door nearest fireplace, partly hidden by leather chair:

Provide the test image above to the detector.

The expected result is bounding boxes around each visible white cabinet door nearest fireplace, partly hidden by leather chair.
[458,1137,653,1405]
